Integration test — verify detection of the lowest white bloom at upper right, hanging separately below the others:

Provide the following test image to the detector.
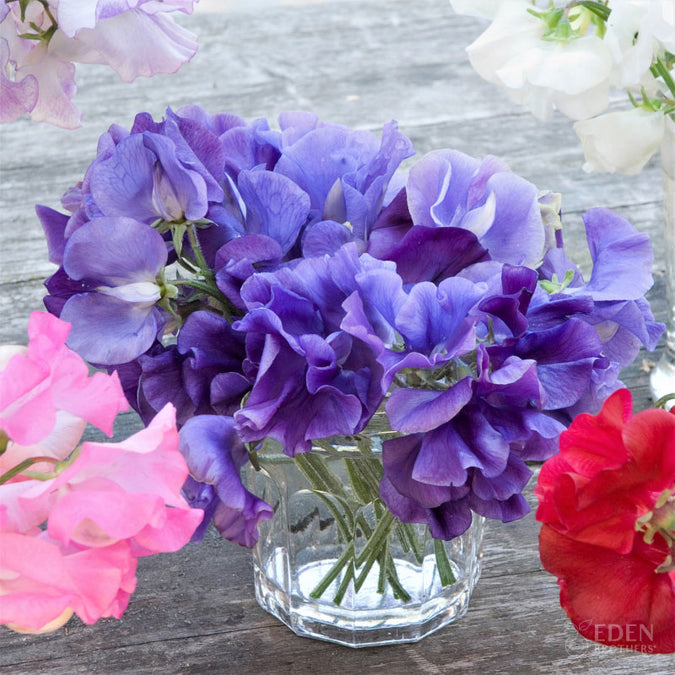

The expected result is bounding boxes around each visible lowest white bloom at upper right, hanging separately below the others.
[574,108,665,175]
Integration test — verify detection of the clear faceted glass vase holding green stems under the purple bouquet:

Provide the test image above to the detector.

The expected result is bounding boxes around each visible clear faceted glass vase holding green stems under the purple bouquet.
[247,415,484,647]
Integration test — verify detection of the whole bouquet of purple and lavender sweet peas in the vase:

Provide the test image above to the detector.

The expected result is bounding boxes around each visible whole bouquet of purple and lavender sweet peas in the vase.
[37,106,663,604]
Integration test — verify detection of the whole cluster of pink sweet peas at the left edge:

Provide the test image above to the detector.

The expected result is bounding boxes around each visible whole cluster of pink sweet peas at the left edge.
[0,312,203,632]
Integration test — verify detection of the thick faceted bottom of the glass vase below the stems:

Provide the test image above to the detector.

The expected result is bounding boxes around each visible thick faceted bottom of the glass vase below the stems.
[254,549,480,647]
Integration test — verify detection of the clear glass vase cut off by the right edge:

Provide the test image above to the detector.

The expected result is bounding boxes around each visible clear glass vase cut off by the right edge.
[650,115,675,401]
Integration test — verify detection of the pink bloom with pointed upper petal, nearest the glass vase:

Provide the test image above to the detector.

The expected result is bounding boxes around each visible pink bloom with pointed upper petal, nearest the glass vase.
[44,404,203,556]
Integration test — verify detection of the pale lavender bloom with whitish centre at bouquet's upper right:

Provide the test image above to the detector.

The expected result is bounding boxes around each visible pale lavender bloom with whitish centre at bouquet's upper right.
[406,150,547,267]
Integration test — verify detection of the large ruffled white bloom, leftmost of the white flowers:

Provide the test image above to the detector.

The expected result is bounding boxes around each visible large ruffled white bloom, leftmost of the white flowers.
[467,0,614,120]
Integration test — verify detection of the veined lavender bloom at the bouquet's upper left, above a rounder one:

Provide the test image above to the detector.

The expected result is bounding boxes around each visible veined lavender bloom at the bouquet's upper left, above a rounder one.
[37,107,234,265]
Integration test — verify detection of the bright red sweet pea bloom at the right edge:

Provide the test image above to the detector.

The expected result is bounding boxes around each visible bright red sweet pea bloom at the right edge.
[535,389,675,653]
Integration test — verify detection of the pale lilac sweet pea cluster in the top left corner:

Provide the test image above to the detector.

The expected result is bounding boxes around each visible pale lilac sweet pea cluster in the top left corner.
[0,0,198,128]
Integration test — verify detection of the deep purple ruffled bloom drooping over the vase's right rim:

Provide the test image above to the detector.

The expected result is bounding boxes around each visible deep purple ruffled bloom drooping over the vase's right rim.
[381,345,564,539]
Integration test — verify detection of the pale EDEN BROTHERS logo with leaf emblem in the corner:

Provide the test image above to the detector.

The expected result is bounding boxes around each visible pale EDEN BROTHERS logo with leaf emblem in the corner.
[565,620,654,655]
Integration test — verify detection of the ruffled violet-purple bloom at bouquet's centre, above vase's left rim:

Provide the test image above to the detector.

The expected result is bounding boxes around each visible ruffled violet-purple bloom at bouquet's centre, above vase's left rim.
[234,244,400,455]
